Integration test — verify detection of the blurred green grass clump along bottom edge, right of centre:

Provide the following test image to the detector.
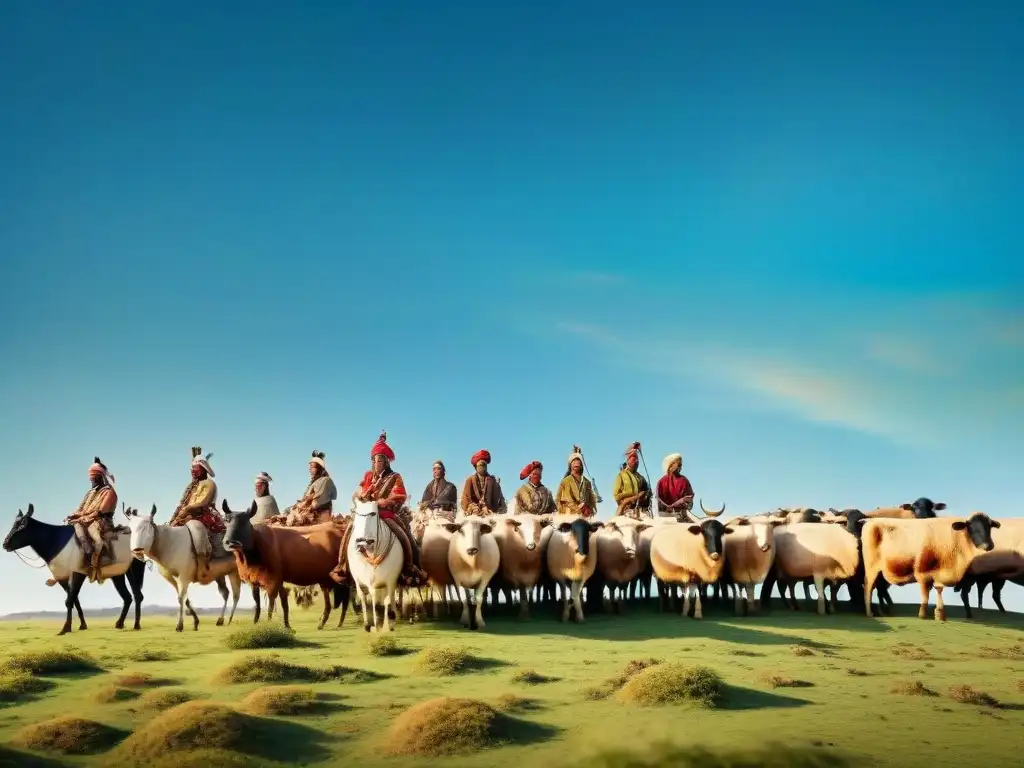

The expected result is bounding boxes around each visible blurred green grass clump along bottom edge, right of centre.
[578,743,856,768]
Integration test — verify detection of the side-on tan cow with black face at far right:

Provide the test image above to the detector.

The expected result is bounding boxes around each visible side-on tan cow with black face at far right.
[856,512,999,622]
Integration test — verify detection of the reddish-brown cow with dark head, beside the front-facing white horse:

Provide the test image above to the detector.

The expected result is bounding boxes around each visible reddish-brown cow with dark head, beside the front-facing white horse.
[222,499,349,630]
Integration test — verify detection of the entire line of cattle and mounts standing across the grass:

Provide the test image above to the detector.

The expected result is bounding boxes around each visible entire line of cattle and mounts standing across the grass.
[4,498,1024,634]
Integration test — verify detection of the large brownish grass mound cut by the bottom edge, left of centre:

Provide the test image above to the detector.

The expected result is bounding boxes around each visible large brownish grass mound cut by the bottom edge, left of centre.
[111,701,260,765]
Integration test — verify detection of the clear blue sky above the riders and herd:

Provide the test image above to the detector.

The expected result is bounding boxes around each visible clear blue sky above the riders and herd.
[0,1,1024,612]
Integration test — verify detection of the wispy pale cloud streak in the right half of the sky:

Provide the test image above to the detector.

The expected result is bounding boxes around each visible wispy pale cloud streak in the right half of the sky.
[558,302,1022,444]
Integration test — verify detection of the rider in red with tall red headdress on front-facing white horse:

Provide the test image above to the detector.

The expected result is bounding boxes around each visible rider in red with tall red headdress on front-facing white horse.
[331,432,426,587]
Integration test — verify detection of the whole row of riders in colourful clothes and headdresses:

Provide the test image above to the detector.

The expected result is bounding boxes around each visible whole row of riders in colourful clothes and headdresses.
[58,432,693,586]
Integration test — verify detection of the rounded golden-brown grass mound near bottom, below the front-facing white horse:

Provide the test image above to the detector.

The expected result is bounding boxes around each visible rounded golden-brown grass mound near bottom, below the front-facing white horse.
[388,696,524,758]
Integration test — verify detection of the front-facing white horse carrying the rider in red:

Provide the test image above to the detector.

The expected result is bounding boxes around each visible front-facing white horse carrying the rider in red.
[345,501,404,632]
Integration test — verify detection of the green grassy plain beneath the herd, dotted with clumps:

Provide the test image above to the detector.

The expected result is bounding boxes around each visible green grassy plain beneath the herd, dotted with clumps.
[0,605,1024,768]
